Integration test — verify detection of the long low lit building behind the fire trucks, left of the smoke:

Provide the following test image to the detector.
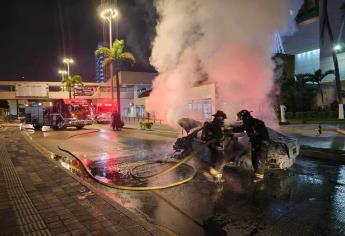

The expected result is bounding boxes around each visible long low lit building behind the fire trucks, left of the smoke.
[0,71,156,117]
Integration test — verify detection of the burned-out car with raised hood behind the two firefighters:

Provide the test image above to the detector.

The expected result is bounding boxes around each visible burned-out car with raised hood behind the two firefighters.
[173,118,300,170]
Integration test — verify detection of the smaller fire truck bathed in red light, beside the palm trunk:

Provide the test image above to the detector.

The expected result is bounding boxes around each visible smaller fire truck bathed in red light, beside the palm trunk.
[94,99,116,124]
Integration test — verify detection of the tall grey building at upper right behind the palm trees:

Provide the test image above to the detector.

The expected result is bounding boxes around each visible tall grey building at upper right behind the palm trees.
[283,0,345,105]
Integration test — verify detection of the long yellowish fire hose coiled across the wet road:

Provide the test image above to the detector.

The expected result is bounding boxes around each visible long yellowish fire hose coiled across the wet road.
[58,129,216,191]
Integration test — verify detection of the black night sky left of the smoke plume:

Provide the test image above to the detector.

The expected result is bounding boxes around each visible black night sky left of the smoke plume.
[0,0,157,82]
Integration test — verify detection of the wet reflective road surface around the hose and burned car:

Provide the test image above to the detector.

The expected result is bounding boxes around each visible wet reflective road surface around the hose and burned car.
[27,124,345,235]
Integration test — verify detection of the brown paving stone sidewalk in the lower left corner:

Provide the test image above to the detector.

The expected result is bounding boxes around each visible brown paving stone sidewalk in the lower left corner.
[0,128,161,236]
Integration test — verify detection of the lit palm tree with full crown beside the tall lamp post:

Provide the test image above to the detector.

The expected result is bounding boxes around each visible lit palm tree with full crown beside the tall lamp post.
[95,39,135,117]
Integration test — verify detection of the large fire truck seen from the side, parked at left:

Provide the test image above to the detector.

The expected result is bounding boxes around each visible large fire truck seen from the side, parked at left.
[25,99,93,130]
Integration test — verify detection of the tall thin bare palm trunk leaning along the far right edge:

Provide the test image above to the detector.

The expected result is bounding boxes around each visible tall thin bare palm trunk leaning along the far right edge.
[320,0,344,119]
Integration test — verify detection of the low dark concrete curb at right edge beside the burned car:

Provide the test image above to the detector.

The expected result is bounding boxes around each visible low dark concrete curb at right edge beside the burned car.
[301,145,345,164]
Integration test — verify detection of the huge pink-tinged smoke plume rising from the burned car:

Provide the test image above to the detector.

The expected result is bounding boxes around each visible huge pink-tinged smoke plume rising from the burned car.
[147,0,300,125]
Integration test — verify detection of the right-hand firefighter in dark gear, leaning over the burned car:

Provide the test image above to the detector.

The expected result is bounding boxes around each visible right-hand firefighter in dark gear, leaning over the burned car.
[232,110,269,182]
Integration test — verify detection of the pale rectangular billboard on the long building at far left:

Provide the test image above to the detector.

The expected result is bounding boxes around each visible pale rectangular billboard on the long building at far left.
[16,83,49,98]
